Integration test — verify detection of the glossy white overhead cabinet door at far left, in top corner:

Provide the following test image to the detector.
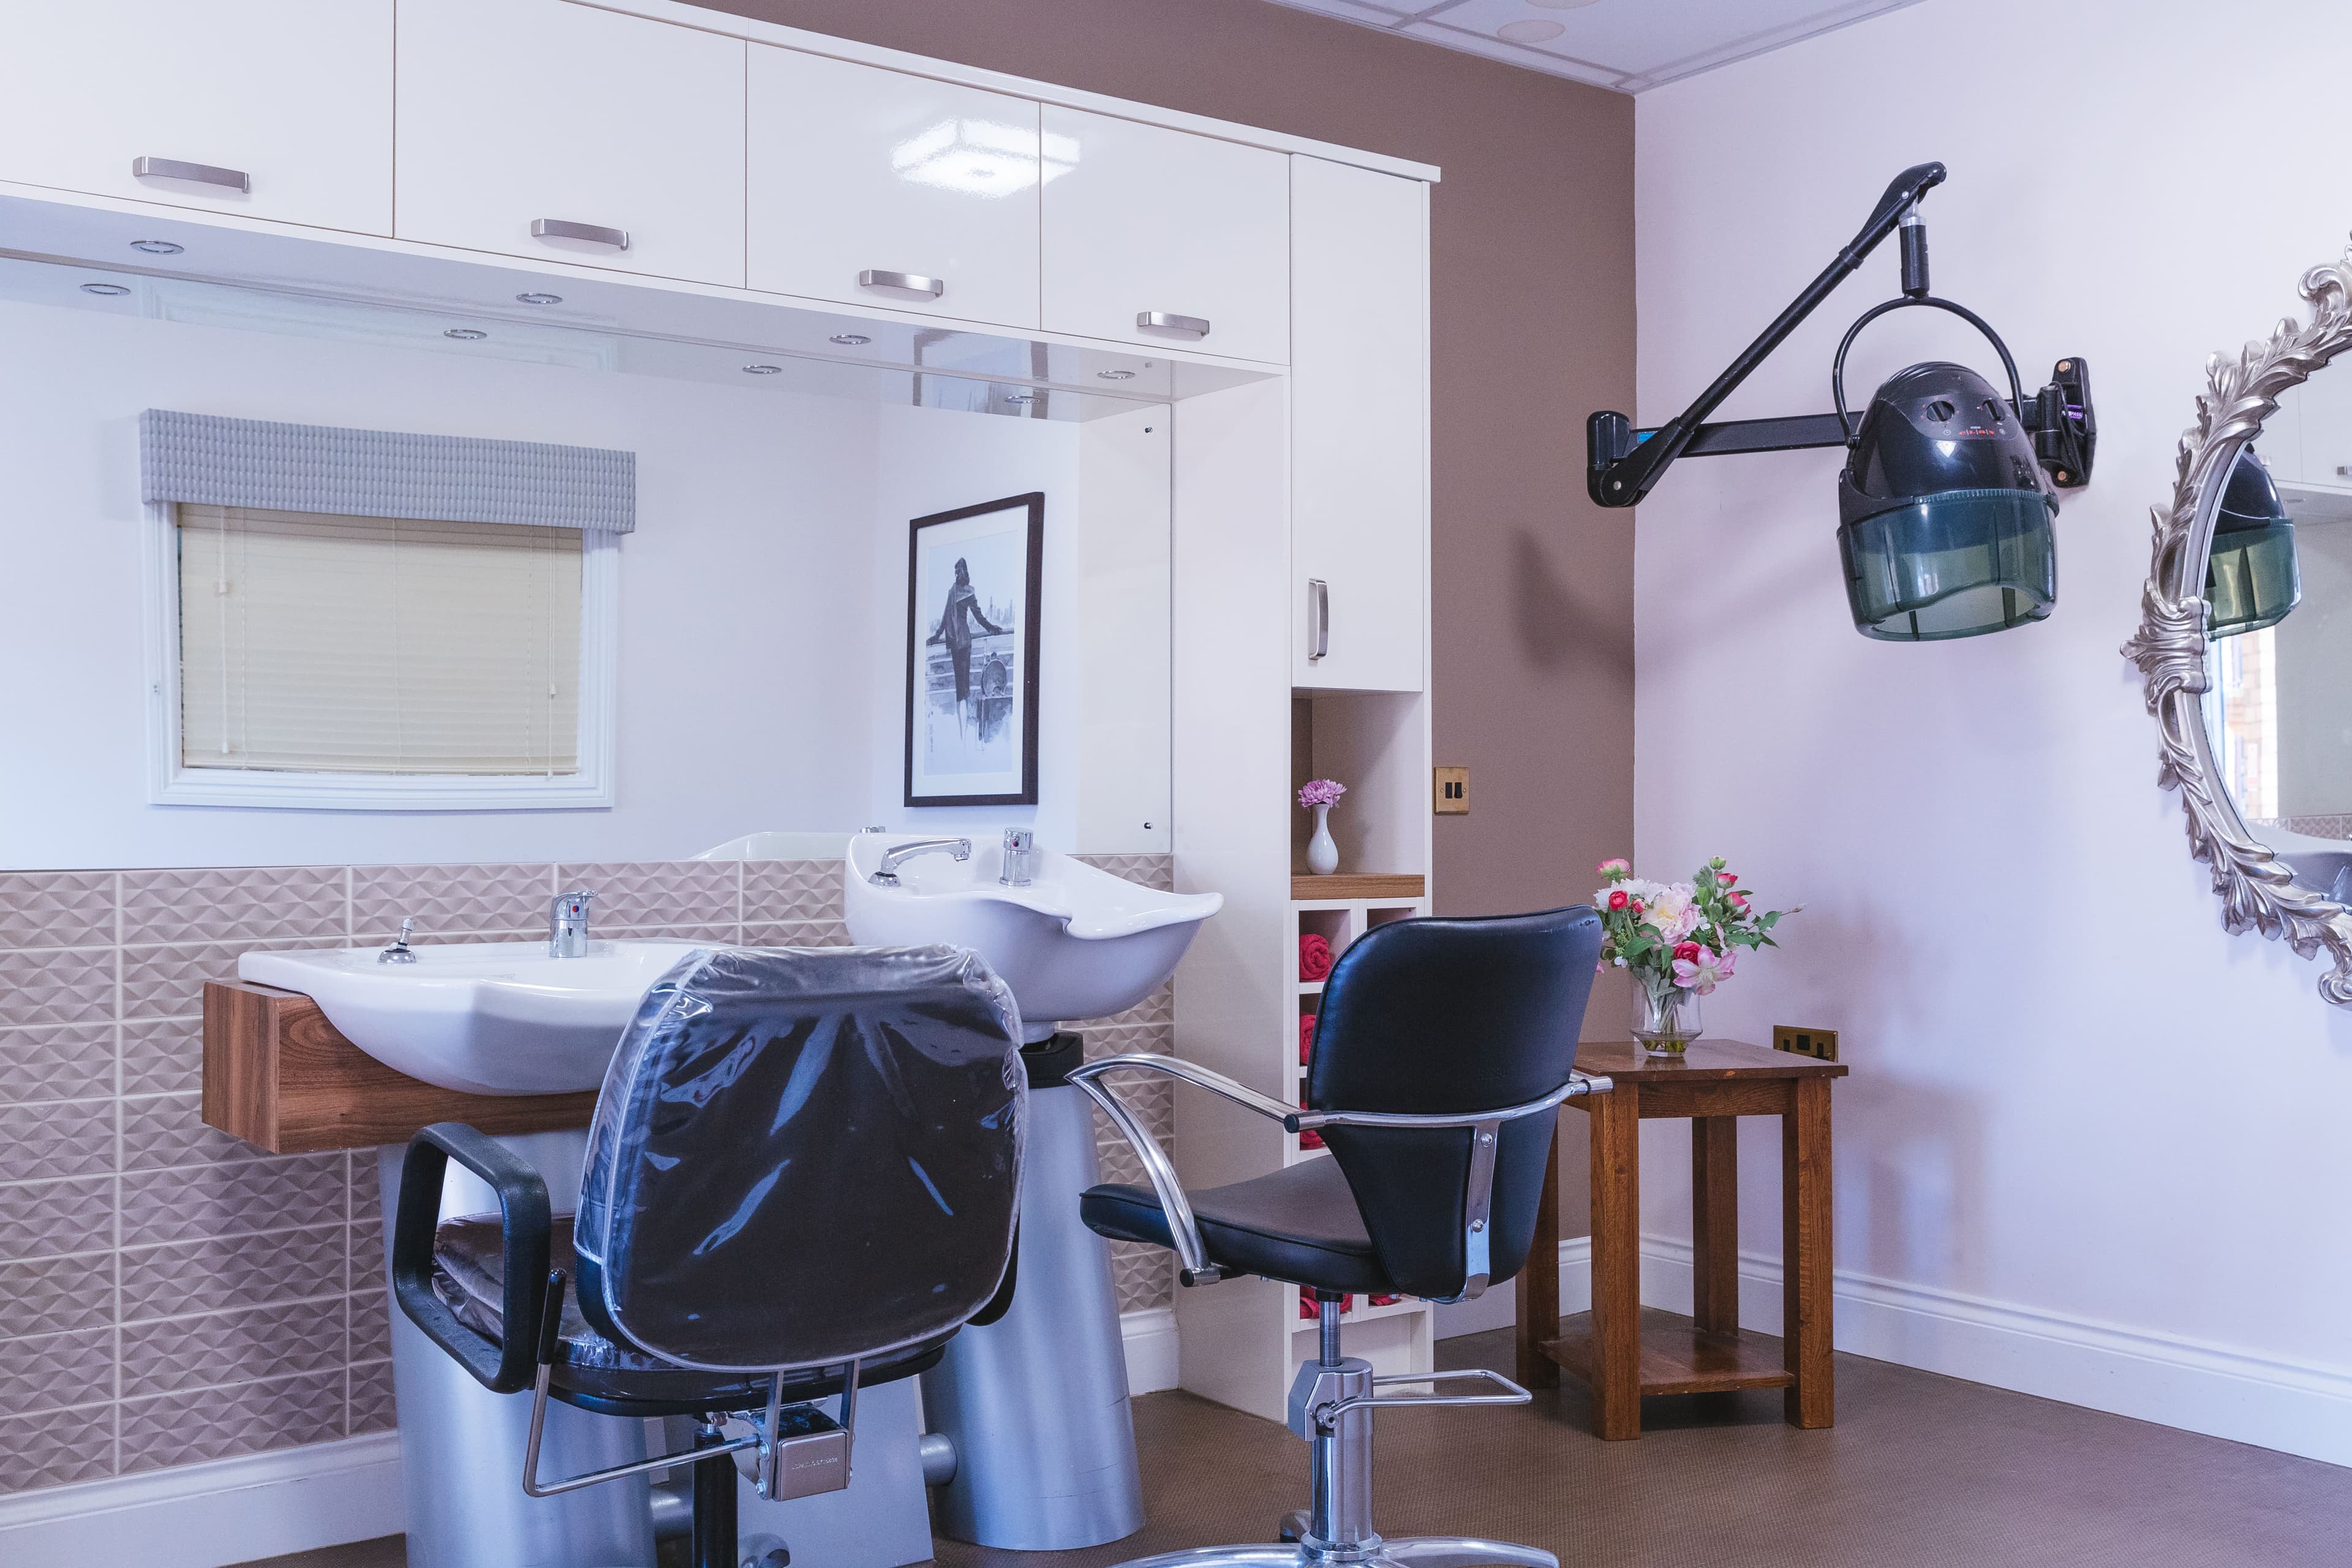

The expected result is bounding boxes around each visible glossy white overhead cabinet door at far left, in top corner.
[0,0,393,235]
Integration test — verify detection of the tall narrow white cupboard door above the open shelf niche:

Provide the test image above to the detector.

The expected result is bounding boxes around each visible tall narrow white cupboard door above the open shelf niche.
[1291,157,1430,691]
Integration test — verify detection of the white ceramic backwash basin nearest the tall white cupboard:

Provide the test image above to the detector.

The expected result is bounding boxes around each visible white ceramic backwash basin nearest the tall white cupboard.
[842,832,1226,1041]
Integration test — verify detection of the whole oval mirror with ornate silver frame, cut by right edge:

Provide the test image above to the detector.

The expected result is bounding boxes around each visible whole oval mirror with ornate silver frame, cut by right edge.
[2124,246,2352,1006]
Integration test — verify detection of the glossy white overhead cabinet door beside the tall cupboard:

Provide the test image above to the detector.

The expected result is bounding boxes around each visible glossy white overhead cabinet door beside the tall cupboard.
[1042,104,1291,364]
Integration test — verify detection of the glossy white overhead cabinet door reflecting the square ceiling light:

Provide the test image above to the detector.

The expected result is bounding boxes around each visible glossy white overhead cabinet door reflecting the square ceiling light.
[745,45,1037,326]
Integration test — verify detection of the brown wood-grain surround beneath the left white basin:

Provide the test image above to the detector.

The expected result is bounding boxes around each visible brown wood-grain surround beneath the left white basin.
[205,980,595,1154]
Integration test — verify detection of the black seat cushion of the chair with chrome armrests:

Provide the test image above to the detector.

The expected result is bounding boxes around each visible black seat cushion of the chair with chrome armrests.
[1080,1159,1397,1295]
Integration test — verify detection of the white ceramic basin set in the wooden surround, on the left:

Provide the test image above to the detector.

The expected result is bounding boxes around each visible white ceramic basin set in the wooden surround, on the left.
[238,943,694,1096]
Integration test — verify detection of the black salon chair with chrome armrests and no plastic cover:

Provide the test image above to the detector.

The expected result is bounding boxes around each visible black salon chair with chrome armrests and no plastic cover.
[1070,907,1609,1568]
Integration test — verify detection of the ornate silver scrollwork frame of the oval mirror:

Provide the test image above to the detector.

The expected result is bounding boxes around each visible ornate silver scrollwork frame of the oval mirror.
[2124,252,2352,1006]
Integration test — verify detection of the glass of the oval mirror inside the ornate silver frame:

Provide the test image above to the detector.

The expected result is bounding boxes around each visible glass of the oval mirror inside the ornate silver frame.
[2204,367,2352,900]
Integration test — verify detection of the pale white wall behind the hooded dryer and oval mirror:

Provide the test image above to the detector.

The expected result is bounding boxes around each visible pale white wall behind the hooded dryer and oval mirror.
[1635,0,2352,1462]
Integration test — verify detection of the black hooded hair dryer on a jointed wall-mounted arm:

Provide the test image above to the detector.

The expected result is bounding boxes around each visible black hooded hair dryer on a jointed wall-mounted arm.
[1585,162,2098,642]
